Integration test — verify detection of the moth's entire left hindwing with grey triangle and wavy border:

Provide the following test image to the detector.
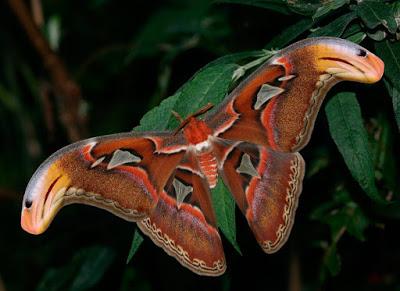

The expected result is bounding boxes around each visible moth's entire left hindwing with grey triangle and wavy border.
[138,152,226,276]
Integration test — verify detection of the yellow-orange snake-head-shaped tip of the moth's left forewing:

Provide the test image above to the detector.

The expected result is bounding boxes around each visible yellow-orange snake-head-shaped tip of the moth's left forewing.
[21,157,70,234]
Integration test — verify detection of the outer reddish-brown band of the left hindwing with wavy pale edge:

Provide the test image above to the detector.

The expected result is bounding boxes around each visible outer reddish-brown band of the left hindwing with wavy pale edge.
[138,193,226,276]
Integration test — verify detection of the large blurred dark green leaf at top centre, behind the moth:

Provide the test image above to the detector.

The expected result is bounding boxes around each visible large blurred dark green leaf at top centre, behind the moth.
[126,0,229,62]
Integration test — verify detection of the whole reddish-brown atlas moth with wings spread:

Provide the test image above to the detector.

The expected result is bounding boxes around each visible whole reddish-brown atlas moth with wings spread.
[21,37,384,276]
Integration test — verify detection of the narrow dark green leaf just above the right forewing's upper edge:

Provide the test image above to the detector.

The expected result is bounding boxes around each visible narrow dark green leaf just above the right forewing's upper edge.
[265,18,314,49]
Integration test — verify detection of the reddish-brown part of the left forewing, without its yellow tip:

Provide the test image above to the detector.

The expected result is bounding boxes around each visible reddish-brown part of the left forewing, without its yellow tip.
[57,135,184,221]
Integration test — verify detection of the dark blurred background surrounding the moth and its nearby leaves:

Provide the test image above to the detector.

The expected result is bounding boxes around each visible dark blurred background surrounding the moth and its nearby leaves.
[0,0,400,291]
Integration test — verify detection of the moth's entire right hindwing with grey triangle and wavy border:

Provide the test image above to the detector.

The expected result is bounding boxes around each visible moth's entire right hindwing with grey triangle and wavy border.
[217,143,304,253]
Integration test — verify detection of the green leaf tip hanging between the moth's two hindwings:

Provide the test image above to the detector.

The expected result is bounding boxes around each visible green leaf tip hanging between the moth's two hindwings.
[212,179,242,254]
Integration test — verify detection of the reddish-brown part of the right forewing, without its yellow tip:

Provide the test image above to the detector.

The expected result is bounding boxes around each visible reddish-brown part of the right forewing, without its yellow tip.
[206,47,332,152]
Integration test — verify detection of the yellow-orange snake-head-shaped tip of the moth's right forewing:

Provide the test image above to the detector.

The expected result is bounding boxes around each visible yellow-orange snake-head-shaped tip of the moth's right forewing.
[310,38,384,83]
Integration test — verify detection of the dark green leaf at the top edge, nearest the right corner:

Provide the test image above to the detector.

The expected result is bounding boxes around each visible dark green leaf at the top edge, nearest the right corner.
[355,0,397,33]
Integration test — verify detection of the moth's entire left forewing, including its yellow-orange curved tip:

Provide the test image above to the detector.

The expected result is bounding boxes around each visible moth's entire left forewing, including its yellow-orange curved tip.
[21,133,186,234]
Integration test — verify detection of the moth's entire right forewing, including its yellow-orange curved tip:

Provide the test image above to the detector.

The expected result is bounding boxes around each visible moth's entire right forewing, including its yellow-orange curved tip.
[206,37,384,152]
